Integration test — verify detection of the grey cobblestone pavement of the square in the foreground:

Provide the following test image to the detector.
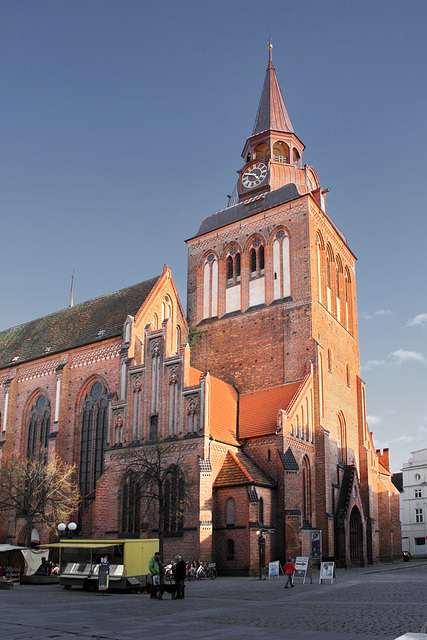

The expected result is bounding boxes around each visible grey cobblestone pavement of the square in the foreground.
[0,561,427,640]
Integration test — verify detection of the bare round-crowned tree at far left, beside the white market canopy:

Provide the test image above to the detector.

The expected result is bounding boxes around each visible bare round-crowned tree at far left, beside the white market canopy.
[0,454,80,546]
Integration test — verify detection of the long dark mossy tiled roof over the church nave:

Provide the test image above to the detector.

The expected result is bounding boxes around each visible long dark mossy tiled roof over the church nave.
[0,276,159,369]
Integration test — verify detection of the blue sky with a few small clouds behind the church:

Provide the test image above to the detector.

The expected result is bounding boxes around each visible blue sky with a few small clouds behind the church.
[0,0,427,471]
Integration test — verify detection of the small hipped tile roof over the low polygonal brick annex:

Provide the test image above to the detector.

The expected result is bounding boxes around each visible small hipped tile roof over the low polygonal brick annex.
[214,451,276,488]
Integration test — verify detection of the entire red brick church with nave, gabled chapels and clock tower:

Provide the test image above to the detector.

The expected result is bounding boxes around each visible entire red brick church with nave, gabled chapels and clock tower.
[0,47,401,575]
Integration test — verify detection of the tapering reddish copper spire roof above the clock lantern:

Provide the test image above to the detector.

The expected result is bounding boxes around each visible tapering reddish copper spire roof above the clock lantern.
[252,45,294,136]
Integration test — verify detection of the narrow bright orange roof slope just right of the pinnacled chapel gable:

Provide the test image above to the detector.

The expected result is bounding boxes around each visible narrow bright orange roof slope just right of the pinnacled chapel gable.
[209,376,238,445]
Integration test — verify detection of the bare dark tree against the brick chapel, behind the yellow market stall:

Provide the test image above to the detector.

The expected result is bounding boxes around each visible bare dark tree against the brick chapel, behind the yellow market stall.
[122,440,195,557]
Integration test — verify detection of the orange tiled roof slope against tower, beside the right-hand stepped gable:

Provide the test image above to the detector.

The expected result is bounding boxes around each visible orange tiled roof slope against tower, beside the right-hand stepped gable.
[239,380,304,438]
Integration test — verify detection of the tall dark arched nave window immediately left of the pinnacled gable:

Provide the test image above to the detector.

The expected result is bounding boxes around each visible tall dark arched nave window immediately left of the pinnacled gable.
[79,380,108,498]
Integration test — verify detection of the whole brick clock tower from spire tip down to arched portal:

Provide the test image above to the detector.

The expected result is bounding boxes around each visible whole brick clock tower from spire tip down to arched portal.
[187,45,390,564]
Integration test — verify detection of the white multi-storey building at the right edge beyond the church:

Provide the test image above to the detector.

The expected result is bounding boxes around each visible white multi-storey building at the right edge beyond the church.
[401,449,427,556]
